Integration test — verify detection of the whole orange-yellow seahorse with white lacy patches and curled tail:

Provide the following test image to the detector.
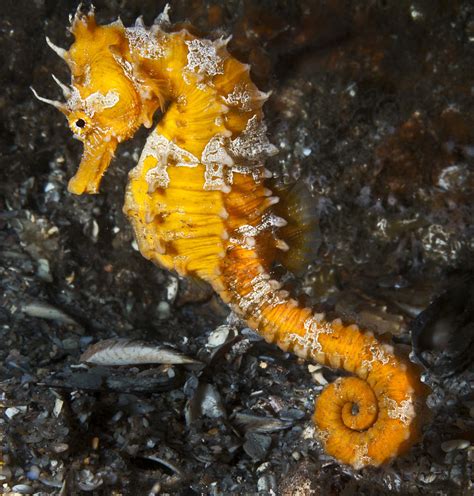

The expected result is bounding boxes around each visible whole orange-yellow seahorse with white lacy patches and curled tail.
[33,5,426,469]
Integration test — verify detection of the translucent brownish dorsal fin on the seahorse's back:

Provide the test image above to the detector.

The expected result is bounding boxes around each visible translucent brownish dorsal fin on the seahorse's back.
[271,181,321,275]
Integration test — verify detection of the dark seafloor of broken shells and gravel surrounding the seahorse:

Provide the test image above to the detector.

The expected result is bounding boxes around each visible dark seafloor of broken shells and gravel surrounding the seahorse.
[0,0,474,495]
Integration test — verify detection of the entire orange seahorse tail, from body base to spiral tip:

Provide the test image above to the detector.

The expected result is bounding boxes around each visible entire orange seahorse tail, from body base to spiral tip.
[222,242,425,469]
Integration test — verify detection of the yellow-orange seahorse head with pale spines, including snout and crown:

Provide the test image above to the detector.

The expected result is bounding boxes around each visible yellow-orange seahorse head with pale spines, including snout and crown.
[35,10,159,195]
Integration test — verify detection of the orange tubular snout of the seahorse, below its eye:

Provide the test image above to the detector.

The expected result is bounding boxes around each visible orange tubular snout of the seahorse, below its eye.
[68,137,117,195]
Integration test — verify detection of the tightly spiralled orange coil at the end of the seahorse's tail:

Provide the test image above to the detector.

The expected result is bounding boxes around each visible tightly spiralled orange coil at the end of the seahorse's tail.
[313,354,423,469]
